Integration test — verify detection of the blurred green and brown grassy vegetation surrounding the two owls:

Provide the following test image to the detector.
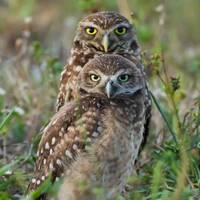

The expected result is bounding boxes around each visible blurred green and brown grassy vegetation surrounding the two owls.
[0,0,200,200]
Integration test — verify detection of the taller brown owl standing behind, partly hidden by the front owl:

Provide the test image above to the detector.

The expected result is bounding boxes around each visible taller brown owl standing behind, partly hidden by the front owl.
[57,12,140,110]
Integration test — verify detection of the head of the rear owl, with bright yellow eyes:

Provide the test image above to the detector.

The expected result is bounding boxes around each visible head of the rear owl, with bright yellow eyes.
[75,12,140,55]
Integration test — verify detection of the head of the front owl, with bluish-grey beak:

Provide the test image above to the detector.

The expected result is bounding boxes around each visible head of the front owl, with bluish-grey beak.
[77,54,145,100]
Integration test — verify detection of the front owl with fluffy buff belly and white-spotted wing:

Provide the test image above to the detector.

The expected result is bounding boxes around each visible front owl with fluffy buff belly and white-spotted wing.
[29,55,147,200]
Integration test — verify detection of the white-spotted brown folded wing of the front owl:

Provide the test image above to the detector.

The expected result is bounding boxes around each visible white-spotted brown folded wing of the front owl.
[28,102,98,194]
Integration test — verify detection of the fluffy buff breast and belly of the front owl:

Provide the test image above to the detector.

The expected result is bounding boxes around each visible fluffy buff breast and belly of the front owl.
[58,98,145,200]
